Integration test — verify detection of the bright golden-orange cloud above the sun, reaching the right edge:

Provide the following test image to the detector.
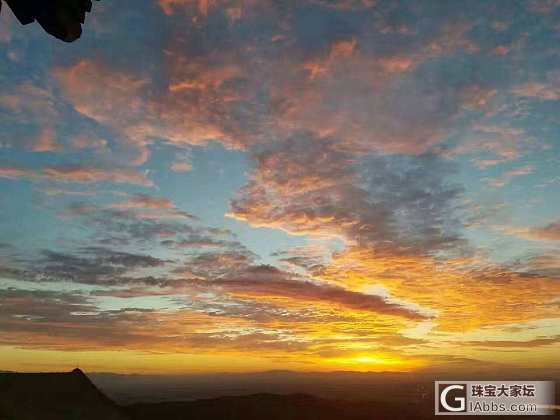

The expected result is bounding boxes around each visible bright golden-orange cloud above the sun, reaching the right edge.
[320,248,560,332]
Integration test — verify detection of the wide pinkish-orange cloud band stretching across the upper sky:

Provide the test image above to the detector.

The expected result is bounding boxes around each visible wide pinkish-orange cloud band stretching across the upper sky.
[53,13,486,164]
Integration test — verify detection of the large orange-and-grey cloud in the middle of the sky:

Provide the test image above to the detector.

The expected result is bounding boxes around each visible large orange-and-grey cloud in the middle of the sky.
[229,135,461,253]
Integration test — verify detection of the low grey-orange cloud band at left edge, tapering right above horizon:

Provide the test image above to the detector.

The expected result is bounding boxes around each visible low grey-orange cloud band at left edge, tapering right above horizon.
[0,289,318,354]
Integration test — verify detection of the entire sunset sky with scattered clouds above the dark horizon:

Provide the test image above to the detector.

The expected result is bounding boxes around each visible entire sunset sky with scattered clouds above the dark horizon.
[0,0,560,373]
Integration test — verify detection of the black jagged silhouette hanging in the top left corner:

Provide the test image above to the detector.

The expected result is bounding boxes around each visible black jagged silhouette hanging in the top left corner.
[0,0,99,42]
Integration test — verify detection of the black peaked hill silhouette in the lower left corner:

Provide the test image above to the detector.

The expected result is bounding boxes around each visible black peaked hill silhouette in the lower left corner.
[0,369,128,420]
